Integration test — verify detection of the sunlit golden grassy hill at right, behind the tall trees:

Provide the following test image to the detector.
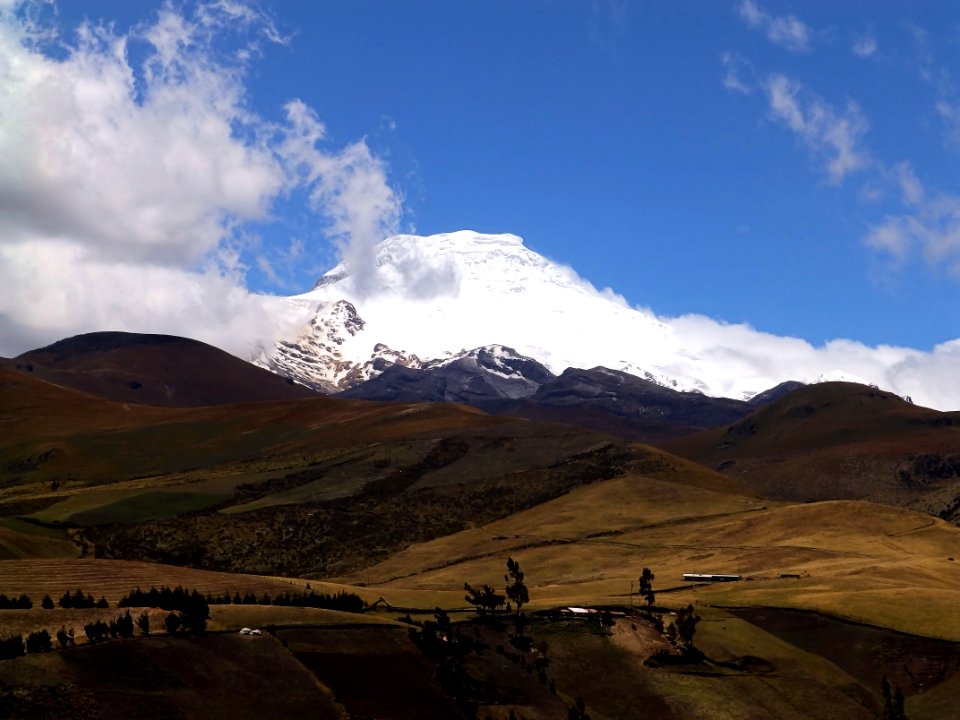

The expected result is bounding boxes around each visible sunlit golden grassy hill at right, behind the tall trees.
[341,477,960,640]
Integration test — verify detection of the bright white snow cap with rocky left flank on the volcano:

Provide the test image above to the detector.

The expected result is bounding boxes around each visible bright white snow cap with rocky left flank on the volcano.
[258,231,705,389]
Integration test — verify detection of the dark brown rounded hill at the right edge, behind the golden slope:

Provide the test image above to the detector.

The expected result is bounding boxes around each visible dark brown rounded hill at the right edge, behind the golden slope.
[659,383,960,520]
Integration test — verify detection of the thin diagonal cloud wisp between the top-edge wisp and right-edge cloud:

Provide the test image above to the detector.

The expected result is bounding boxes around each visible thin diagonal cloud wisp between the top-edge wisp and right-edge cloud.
[765,74,869,183]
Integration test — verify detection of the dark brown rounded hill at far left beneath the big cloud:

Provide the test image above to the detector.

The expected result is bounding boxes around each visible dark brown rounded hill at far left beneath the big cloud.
[12,332,316,407]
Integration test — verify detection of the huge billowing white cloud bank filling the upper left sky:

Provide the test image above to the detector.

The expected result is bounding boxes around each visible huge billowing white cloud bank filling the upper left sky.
[0,0,400,355]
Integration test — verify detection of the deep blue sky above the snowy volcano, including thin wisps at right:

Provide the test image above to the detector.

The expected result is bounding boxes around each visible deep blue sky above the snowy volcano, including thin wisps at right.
[0,0,960,360]
